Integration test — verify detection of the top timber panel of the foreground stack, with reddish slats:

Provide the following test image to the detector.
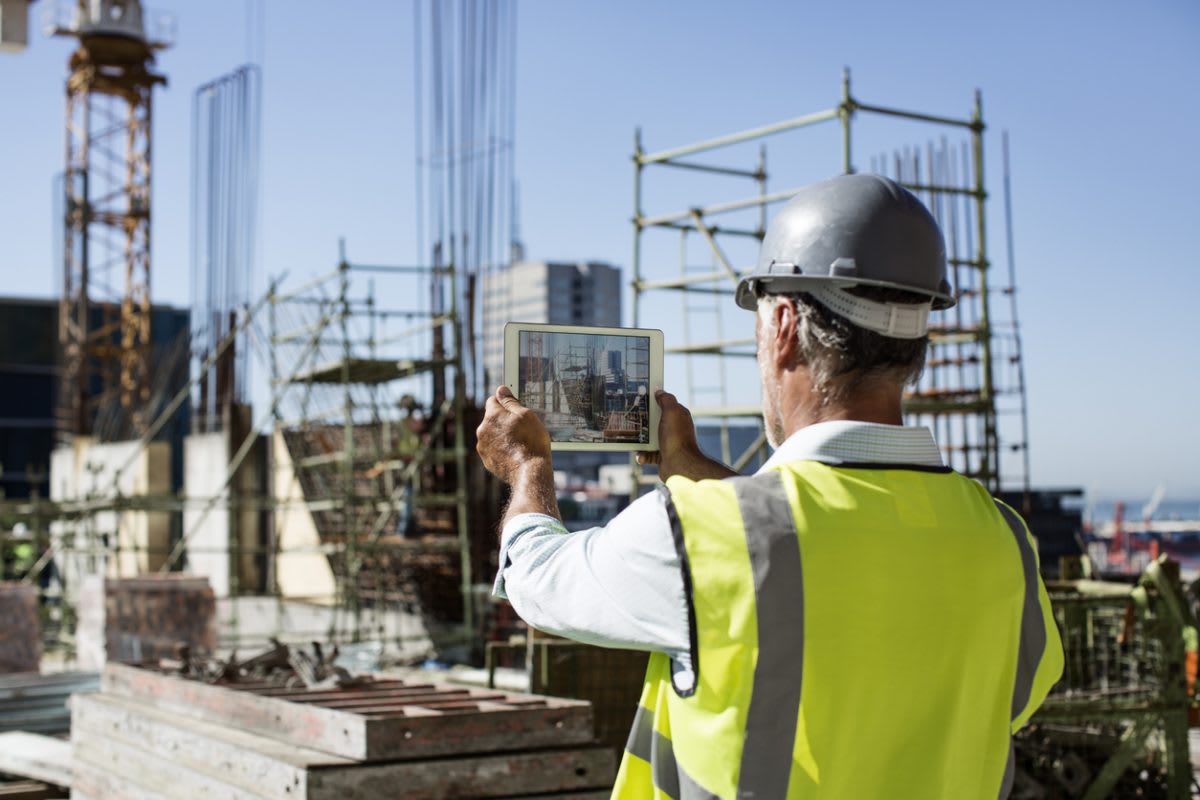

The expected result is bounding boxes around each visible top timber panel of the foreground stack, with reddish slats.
[102,663,593,760]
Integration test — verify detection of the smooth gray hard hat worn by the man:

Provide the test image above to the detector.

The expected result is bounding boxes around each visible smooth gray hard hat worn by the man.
[737,175,955,309]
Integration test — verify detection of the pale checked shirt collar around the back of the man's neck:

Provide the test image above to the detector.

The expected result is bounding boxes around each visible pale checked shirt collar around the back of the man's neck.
[758,420,944,471]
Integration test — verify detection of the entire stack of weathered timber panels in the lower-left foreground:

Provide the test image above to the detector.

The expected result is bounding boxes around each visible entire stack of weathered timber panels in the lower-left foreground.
[71,663,616,800]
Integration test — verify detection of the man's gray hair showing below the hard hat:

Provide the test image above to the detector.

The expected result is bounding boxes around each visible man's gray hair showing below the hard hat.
[758,287,929,404]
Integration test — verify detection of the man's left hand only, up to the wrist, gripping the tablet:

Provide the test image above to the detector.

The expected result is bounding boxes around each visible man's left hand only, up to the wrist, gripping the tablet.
[475,386,551,486]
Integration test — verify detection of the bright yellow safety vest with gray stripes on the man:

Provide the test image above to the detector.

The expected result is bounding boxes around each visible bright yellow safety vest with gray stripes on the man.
[613,461,1062,800]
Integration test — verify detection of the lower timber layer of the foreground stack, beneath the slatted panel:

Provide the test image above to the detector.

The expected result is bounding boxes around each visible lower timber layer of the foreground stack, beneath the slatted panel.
[72,694,613,800]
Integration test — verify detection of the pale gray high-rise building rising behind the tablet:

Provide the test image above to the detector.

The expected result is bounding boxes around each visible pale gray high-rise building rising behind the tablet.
[484,261,620,387]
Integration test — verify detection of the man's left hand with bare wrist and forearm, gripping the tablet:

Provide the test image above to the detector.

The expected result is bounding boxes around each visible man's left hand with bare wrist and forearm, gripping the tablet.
[475,386,560,524]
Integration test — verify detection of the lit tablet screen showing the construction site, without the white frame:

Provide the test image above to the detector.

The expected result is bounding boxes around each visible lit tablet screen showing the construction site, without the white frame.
[517,330,650,445]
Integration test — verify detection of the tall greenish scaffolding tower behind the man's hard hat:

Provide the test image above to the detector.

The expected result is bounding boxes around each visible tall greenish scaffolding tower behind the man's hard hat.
[631,71,1028,492]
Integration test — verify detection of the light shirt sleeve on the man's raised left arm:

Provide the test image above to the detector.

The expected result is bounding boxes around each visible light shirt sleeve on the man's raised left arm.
[493,492,689,660]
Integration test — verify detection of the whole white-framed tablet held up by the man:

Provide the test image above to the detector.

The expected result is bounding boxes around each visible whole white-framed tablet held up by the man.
[504,323,662,451]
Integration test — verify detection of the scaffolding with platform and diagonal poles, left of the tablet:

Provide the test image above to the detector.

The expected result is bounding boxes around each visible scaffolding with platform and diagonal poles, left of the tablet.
[0,253,499,658]
